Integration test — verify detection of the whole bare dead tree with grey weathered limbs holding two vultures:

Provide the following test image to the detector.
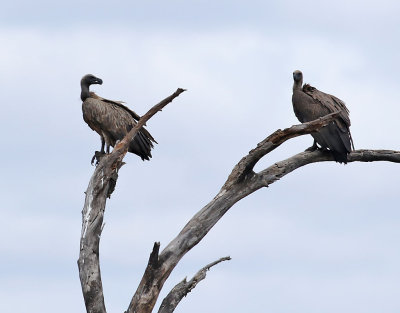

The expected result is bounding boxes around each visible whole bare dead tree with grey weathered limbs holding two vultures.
[78,89,400,313]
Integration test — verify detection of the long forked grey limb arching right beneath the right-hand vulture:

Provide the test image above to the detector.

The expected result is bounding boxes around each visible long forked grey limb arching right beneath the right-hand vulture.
[126,112,400,313]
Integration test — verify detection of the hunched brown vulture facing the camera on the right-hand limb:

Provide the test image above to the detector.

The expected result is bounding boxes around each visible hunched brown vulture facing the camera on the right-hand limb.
[292,70,354,164]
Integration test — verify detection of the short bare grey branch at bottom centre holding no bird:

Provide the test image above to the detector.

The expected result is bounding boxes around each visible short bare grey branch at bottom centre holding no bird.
[158,256,231,313]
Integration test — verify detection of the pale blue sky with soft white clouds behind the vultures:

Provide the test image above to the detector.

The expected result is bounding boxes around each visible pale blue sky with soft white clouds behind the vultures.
[0,0,400,313]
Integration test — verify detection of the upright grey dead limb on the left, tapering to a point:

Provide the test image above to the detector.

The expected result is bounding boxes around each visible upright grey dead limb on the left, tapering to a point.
[78,88,184,313]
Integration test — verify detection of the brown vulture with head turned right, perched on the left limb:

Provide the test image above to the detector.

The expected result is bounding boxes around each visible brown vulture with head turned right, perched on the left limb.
[81,74,157,163]
